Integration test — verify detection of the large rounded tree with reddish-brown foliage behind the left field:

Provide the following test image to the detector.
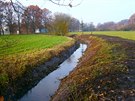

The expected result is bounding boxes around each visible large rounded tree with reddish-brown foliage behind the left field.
[23,5,42,33]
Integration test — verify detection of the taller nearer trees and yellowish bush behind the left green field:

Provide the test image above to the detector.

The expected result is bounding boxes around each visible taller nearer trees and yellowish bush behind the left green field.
[0,0,80,35]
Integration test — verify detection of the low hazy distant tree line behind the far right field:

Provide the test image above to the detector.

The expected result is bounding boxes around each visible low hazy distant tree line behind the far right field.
[83,14,135,31]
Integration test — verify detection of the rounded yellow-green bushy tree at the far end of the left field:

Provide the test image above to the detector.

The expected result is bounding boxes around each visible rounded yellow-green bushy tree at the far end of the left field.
[53,13,71,35]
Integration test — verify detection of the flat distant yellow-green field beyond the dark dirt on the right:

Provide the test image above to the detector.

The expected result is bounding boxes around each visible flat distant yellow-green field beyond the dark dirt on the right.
[71,31,135,40]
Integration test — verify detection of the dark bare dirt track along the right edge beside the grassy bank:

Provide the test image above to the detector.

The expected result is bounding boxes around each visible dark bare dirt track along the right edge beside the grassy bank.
[96,36,135,101]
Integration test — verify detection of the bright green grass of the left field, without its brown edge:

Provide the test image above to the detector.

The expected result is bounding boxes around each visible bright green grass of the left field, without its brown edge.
[0,35,68,56]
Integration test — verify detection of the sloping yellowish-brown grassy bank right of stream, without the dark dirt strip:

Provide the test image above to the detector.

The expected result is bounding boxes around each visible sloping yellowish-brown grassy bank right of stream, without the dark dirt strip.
[53,35,127,101]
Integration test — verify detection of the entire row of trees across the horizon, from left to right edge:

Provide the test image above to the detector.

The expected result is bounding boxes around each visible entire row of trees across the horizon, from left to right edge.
[0,0,135,35]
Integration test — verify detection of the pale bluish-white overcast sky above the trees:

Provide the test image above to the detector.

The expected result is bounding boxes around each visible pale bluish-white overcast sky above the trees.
[13,0,135,24]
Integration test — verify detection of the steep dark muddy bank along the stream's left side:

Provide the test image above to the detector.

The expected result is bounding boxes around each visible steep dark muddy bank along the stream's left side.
[4,42,79,101]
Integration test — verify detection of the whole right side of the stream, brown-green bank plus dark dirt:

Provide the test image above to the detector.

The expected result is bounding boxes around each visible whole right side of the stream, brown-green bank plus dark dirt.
[52,35,135,101]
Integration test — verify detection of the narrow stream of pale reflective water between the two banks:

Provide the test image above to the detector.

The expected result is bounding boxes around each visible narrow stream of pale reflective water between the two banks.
[18,44,87,101]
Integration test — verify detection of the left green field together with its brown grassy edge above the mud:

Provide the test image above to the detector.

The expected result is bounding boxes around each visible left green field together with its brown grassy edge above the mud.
[0,35,75,93]
